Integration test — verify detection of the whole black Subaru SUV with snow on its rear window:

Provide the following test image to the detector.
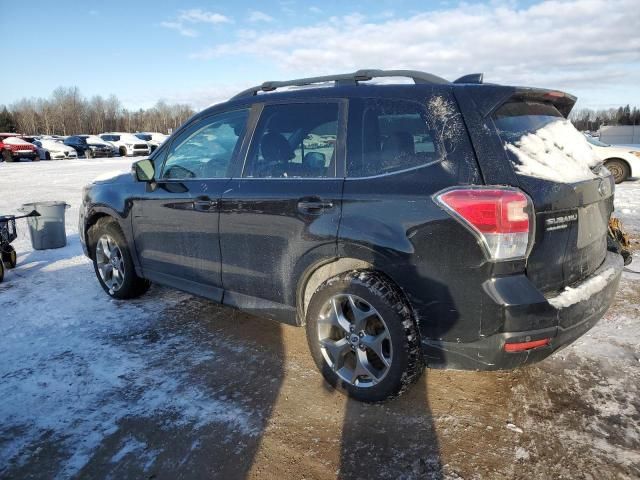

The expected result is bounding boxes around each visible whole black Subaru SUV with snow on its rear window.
[79,70,623,401]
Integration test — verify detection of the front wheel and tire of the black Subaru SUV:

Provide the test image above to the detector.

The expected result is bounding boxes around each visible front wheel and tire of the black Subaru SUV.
[88,217,151,300]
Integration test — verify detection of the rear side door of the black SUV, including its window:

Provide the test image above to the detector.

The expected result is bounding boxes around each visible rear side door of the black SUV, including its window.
[220,100,346,323]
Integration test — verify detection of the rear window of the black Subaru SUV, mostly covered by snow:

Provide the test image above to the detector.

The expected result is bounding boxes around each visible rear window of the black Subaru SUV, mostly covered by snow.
[493,102,600,183]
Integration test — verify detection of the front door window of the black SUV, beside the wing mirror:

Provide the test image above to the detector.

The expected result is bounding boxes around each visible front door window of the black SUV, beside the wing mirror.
[161,109,249,180]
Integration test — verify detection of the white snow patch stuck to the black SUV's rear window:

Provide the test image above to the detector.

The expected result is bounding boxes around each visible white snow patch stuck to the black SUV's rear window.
[506,120,600,183]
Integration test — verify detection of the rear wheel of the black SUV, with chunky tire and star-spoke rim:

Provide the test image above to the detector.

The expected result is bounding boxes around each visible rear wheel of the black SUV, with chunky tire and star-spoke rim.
[307,270,423,402]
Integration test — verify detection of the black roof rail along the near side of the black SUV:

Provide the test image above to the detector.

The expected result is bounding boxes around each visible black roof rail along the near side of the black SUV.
[231,69,449,100]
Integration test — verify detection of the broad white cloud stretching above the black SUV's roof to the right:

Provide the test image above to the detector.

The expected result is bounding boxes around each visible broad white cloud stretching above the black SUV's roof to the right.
[190,0,640,101]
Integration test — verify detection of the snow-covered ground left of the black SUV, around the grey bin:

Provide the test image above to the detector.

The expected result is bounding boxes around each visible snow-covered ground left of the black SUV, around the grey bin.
[0,158,260,478]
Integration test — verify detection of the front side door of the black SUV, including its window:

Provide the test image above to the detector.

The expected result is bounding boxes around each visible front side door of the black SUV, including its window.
[133,109,249,301]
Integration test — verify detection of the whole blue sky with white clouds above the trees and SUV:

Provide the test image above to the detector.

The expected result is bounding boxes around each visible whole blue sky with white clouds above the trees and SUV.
[0,0,640,108]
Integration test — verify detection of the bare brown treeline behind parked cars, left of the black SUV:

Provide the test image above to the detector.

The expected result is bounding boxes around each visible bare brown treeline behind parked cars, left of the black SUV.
[0,87,194,135]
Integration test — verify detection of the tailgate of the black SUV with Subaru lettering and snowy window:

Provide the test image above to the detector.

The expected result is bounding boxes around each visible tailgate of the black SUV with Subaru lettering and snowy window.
[479,91,614,295]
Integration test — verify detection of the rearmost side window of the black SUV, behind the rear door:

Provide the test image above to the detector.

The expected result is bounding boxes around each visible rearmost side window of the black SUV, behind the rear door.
[347,99,440,177]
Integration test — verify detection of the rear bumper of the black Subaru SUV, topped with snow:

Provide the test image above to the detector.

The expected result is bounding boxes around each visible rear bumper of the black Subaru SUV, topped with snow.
[422,252,624,370]
